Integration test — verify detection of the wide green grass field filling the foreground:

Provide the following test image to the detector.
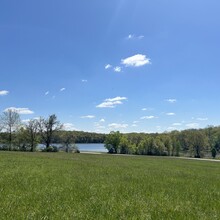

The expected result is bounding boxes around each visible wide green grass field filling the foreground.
[0,152,220,220]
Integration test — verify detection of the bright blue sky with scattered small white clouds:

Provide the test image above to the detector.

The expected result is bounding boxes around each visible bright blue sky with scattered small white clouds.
[0,0,220,133]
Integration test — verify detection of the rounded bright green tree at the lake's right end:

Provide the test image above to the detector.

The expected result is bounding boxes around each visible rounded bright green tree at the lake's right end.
[105,131,121,154]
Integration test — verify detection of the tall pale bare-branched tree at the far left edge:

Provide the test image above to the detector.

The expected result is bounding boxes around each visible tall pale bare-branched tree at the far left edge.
[0,109,20,151]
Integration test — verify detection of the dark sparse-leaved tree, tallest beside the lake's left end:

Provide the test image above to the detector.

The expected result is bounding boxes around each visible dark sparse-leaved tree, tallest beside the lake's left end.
[38,114,62,150]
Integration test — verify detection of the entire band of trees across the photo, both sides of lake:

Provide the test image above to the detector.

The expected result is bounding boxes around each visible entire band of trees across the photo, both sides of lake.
[0,109,220,158]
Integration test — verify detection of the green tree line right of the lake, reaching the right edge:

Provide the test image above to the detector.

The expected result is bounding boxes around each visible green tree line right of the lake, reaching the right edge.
[105,126,220,158]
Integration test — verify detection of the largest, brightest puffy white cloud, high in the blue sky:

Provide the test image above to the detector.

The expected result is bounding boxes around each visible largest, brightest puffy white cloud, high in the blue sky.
[121,54,151,67]
